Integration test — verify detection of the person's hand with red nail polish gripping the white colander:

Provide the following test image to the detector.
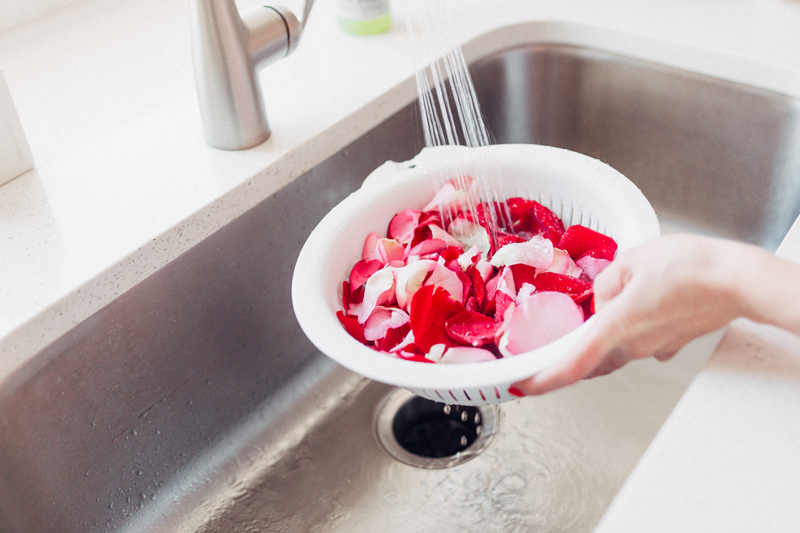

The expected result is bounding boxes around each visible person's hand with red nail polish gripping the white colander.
[514,235,752,395]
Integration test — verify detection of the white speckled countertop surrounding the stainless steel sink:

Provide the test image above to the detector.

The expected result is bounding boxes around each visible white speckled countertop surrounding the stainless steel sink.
[0,0,800,531]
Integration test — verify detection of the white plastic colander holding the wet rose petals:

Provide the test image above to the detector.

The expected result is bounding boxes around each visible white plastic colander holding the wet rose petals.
[292,144,660,405]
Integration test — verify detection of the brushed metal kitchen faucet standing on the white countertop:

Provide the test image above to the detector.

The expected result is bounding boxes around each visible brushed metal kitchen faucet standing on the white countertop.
[190,0,314,150]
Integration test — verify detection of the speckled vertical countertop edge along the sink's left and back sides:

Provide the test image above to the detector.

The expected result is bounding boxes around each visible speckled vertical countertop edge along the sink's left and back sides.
[0,20,800,387]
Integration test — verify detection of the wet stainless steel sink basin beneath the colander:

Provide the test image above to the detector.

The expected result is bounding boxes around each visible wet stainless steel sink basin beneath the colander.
[0,22,800,532]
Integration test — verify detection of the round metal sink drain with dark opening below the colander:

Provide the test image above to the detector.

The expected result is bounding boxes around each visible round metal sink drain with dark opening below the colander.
[375,389,497,468]
